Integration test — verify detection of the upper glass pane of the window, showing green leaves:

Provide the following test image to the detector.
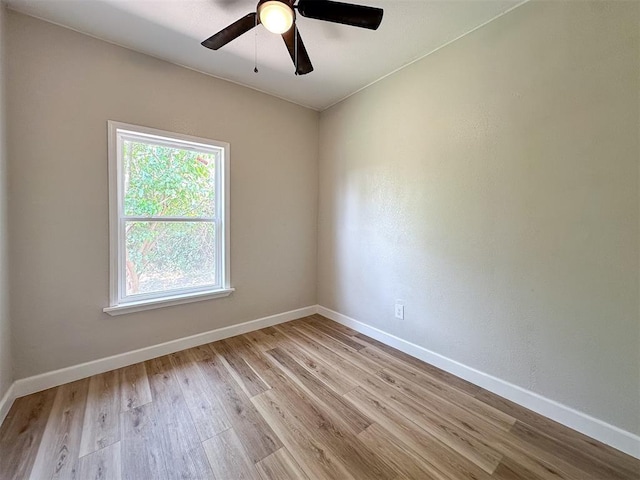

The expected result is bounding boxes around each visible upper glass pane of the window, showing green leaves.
[122,139,216,217]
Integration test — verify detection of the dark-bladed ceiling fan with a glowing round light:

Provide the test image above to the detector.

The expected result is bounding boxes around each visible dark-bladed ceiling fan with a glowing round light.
[202,0,383,75]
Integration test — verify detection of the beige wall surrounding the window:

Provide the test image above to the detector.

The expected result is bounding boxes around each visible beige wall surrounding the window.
[8,12,318,378]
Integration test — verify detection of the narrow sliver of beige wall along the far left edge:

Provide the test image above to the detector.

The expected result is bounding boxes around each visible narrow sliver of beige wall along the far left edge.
[0,3,13,399]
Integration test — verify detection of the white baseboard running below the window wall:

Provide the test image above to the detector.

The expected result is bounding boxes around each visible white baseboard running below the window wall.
[0,305,317,424]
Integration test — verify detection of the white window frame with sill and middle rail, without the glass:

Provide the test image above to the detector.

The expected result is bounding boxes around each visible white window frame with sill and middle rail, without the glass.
[103,120,234,315]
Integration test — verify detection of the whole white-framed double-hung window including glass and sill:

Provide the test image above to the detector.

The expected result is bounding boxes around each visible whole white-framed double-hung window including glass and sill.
[104,122,233,315]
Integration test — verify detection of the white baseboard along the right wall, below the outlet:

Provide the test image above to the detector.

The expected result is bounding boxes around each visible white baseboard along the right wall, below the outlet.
[317,305,640,459]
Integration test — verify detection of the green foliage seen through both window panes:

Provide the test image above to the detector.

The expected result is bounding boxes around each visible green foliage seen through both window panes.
[122,139,216,295]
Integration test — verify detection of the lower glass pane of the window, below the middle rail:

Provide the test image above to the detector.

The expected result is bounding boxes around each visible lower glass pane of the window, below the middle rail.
[126,222,216,295]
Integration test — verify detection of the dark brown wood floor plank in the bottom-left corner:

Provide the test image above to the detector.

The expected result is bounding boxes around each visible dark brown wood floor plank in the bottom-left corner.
[0,388,57,480]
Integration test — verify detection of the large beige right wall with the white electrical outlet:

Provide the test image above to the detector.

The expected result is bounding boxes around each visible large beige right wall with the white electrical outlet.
[318,2,640,434]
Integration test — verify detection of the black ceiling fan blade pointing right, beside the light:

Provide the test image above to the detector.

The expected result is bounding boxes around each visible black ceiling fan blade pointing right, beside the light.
[298,0,384,30]
